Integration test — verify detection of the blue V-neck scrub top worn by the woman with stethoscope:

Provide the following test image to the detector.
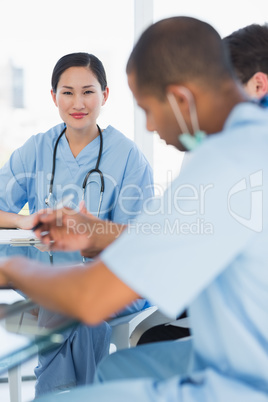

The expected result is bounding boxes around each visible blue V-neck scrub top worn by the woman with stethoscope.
[0,123,153,223]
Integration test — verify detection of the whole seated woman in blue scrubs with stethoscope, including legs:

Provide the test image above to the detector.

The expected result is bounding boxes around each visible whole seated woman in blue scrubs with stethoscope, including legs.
[0,53,153,395]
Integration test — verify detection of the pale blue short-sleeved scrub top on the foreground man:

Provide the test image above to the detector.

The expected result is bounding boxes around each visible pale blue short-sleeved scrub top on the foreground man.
[101,103,268,402]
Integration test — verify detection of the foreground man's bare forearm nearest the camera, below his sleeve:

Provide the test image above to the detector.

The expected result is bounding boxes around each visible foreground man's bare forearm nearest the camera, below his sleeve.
[0,258,138,325]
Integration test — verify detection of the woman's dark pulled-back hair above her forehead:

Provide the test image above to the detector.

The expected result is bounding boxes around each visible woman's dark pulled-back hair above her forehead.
[51,53,107,93]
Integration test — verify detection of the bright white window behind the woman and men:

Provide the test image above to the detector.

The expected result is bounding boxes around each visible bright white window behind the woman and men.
[0,0,267,187]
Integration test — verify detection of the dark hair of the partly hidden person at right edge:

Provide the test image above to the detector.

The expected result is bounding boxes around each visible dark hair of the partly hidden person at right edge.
[223,24,268,84]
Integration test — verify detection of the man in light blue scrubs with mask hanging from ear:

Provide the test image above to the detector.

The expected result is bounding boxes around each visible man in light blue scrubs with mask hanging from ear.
[0,17,268,402]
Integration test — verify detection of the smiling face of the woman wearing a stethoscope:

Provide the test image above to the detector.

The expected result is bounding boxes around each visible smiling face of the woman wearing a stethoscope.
[51,67,109,131]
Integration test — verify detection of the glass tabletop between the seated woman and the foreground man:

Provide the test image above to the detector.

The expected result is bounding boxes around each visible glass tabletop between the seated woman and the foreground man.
[0,244,83,374]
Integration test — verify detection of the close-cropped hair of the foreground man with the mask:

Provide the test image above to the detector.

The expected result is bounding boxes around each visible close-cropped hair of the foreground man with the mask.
[127,17,233,98]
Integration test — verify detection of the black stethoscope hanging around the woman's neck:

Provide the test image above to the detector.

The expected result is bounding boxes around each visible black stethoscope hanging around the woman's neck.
[45,125,104,217]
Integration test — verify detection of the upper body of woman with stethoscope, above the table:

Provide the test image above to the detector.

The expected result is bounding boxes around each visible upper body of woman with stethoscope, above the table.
[0,53,152,229]
